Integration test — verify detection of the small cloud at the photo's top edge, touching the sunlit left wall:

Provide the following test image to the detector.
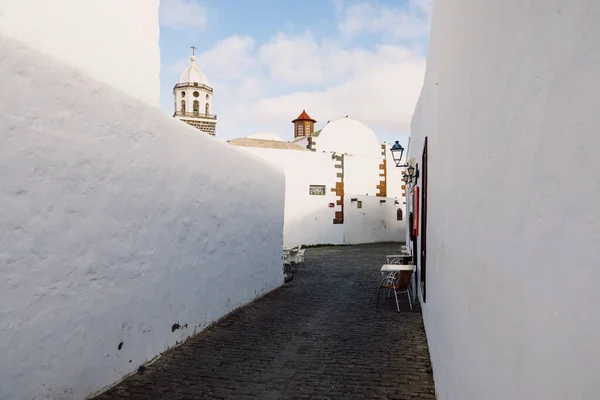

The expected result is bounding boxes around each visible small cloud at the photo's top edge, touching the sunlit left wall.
[160,0,207,29]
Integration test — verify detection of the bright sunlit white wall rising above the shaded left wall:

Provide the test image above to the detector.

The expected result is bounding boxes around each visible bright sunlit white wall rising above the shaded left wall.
[0,0,160,107]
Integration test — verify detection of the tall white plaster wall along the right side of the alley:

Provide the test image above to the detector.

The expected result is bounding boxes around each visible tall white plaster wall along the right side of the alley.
[411,0,600,400]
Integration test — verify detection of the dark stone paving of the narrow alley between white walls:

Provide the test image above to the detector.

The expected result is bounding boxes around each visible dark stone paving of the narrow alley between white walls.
[91,244,435,400]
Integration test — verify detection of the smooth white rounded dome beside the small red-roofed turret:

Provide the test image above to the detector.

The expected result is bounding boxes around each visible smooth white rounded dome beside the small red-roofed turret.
[315,118,381,157]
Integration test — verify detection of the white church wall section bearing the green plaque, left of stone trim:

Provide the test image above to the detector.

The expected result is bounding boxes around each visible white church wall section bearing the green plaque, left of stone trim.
[239,146,344,247]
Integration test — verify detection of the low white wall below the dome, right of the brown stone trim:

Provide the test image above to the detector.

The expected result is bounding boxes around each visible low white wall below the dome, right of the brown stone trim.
[344,195,405,244]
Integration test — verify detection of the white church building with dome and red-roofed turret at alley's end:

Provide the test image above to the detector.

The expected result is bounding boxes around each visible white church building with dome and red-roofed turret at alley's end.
[229,111,406,247]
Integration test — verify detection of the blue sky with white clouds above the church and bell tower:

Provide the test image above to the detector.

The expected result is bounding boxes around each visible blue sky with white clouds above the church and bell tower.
[160,0,432,142]
